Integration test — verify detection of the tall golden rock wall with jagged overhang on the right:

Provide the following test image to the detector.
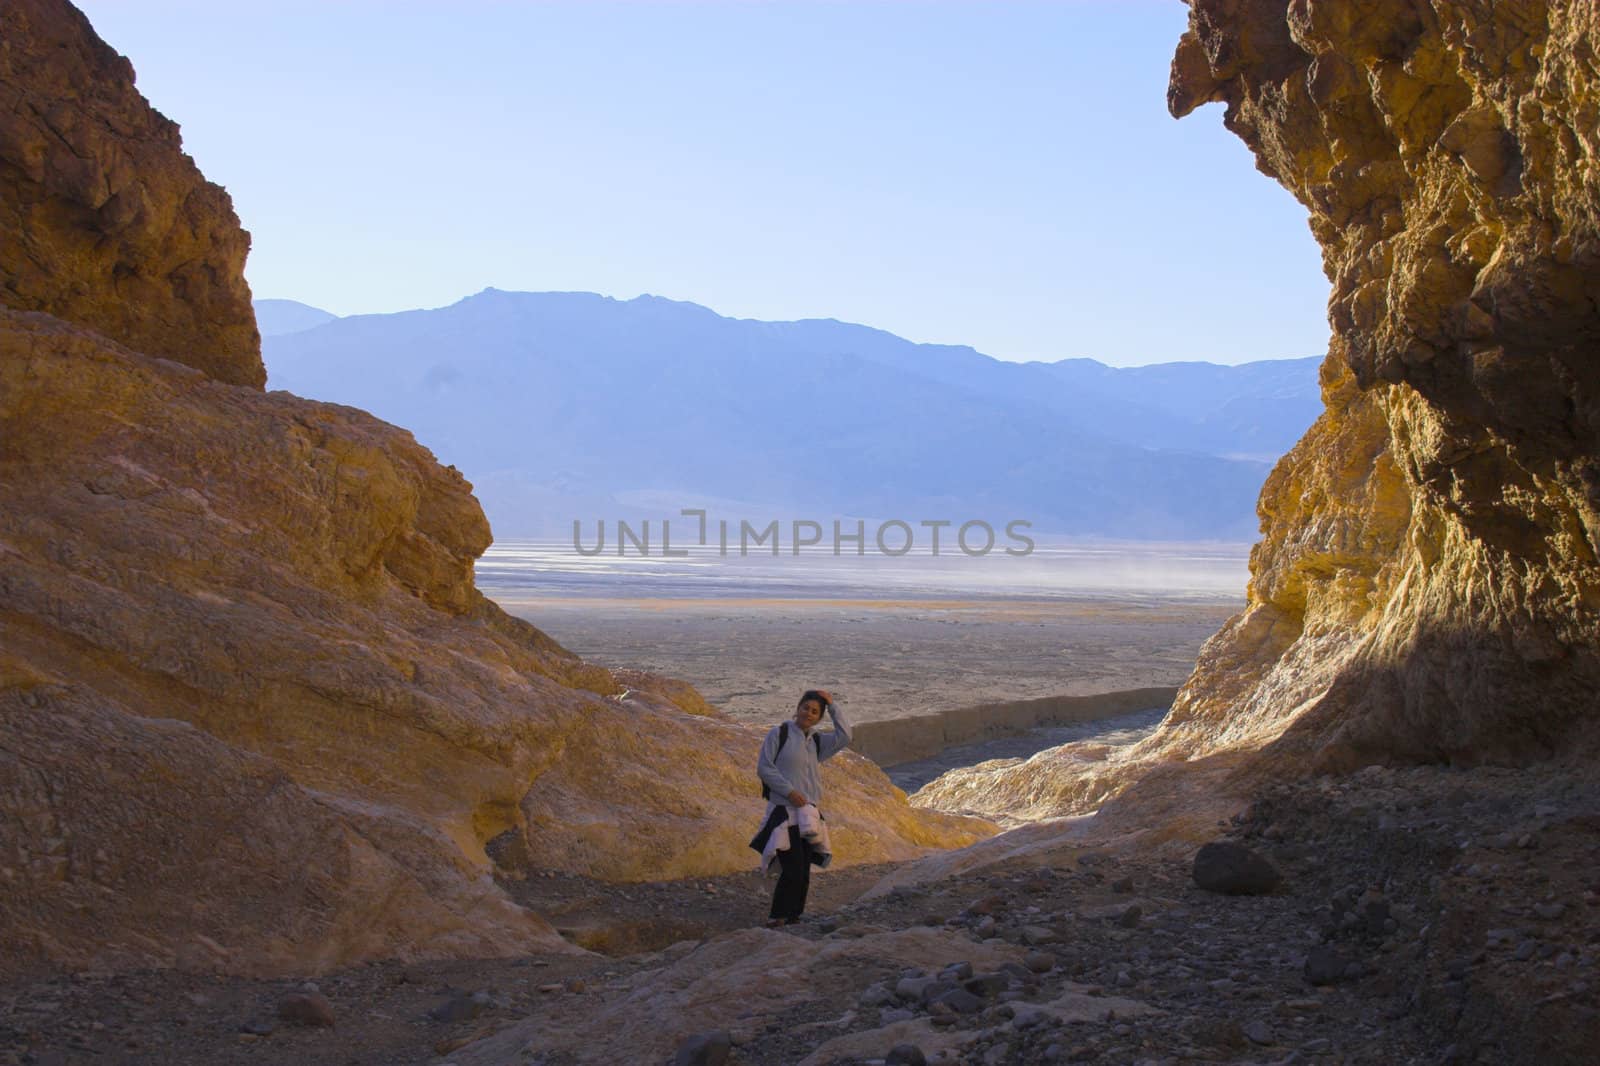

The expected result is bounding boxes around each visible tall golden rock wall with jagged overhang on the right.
[917,0,1600,832]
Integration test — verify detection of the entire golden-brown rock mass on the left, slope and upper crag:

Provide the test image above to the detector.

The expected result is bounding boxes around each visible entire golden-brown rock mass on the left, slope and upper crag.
[0,0,992,973]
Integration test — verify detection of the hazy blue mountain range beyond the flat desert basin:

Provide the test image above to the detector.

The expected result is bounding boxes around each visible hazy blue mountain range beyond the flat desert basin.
[258,288,1322,539]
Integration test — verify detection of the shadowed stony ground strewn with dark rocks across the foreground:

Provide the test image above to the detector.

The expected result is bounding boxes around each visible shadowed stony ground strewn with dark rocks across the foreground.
[0,768,1600,1066]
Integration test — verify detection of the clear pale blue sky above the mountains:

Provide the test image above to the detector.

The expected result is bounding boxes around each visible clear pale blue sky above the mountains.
[80,0,1328,365]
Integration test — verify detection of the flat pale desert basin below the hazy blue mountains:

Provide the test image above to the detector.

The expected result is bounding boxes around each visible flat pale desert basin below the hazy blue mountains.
[478,546,1245,723]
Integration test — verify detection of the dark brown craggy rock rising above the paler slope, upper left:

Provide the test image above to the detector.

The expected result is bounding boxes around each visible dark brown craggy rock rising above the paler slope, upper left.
[0,0,267,387]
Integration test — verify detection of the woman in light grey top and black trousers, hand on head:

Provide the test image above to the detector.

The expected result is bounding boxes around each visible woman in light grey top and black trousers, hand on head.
[750,688,850,928]
